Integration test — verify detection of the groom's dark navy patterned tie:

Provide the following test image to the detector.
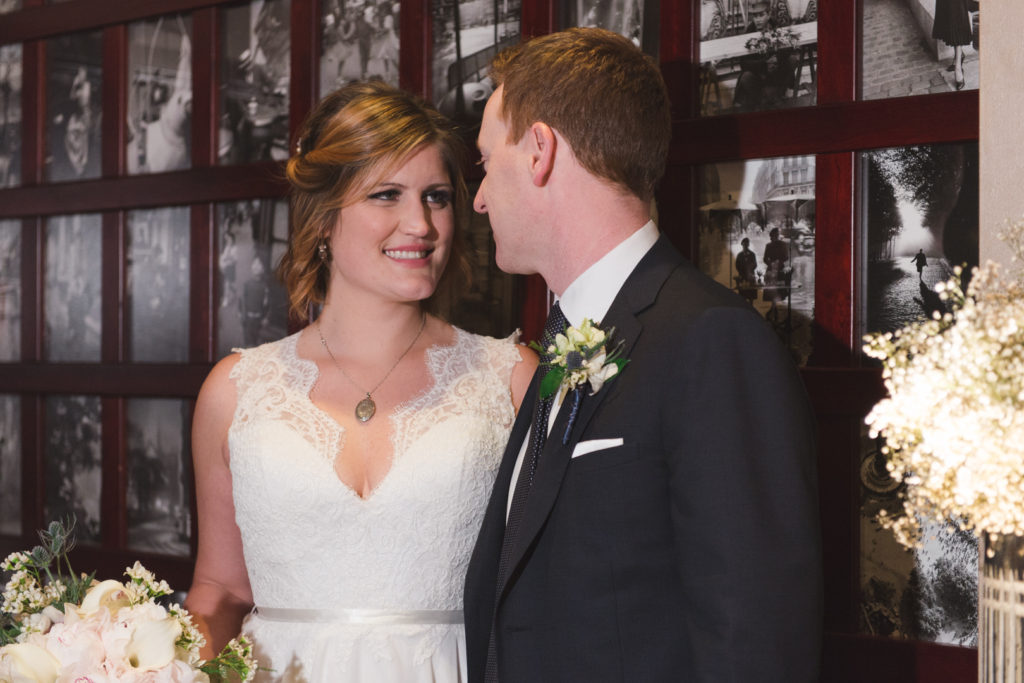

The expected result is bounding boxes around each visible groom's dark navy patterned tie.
[483,303,568,683]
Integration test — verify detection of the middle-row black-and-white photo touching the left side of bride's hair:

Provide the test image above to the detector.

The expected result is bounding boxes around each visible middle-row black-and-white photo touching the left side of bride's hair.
[216,200,288,358]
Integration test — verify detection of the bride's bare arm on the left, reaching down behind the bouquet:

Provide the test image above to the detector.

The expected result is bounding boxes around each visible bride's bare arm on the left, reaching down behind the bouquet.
[184,355,253,658]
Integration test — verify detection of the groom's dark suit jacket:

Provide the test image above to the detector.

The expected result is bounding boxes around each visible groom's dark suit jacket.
[465,237,821,683]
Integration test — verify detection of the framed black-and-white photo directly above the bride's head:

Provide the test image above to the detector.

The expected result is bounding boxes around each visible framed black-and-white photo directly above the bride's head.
[319,0,401,97]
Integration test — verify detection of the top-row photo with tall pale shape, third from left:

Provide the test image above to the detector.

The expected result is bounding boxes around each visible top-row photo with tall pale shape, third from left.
[125,14,191,173]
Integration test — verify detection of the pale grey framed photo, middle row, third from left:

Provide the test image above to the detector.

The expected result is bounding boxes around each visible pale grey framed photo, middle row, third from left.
[126,207,190,362]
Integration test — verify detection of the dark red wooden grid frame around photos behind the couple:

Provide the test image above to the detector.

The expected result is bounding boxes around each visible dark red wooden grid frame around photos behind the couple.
[0,0,978,683]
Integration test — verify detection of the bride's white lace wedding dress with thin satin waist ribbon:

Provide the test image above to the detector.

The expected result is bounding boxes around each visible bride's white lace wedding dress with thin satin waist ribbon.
[228,330,519,683]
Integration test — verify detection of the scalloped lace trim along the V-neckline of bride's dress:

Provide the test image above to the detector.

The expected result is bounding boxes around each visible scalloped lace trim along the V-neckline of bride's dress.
[283,326,469,504]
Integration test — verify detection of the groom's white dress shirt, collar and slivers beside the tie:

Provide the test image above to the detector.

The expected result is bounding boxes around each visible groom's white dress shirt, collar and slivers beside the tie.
[505,220,658,519]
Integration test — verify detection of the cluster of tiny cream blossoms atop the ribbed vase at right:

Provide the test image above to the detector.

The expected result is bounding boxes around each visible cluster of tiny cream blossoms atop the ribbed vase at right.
[864,219,1024,546]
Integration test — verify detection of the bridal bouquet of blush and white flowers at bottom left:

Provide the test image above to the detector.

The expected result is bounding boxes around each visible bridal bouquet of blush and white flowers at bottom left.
[0,522,256,683]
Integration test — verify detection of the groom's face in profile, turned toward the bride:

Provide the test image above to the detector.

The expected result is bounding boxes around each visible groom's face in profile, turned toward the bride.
[473,86,543,273]
